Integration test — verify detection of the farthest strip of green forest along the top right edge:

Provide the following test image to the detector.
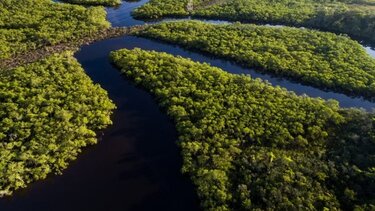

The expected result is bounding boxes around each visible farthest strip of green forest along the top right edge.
[133,0,375,42]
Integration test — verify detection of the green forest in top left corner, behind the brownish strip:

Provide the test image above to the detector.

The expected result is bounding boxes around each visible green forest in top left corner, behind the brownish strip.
[0,0,110,59]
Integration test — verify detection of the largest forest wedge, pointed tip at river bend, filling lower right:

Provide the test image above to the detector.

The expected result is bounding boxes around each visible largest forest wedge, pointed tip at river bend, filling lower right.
[111,48,375,210]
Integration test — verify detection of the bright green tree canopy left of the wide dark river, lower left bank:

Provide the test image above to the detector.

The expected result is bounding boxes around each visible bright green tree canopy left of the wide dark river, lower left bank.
[0,52,115,195]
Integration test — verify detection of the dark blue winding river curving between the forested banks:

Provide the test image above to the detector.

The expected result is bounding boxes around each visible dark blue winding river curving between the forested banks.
[0,0,375,211]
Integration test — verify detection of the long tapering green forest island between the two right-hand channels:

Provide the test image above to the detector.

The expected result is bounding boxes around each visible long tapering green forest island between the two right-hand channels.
[138,21,375,100]
